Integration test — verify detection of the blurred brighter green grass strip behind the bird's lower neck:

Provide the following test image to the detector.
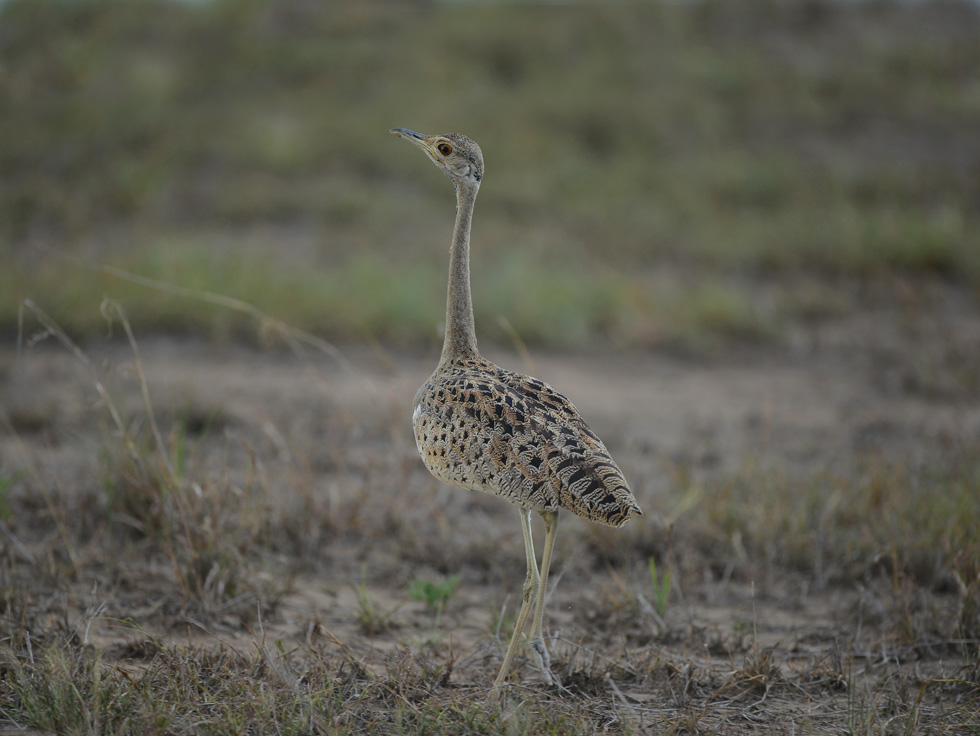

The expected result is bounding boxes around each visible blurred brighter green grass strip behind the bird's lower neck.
[0,239,780,350]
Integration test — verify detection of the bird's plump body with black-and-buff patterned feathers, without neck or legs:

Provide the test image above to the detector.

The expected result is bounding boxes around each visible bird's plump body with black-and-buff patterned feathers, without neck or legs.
[412,355,642,526]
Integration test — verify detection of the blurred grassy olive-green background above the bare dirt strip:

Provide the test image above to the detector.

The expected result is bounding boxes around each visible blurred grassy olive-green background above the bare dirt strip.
[0,0,980,352]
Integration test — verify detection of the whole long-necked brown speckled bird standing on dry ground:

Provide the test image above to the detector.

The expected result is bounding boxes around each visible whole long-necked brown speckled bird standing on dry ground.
[390,128,643,691]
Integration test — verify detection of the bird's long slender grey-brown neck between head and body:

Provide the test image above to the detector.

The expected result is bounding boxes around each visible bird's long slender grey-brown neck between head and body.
[442,183,479,362]
